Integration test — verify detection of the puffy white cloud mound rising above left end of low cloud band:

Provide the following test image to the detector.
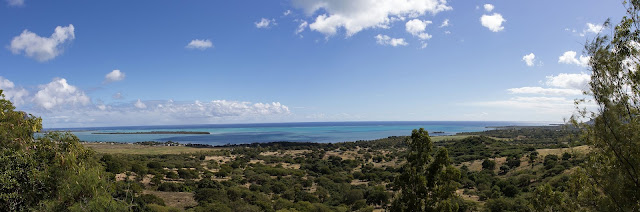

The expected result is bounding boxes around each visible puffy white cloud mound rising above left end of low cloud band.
[33,78,91,110]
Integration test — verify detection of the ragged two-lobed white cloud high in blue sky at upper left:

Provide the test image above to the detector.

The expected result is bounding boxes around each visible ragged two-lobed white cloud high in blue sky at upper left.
[9,24,75,62]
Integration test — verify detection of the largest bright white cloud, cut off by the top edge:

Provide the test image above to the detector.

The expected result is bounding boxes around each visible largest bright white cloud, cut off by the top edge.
[293,0,452,37]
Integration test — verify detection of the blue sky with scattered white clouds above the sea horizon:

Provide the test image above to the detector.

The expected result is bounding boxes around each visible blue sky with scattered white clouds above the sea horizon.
[0,0,625,128]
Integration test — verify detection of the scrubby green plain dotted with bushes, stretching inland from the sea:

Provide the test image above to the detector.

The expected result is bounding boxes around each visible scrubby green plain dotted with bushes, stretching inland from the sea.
[83,126,589,211]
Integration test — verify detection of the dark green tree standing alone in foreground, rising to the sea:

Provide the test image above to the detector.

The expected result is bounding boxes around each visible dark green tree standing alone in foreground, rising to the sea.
[391,128,460,211]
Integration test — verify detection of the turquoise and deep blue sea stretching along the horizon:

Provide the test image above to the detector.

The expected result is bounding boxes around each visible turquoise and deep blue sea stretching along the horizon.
[46,121,554,146]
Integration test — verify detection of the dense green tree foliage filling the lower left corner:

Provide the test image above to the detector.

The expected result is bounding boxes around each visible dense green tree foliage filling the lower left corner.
[0,90,127,211]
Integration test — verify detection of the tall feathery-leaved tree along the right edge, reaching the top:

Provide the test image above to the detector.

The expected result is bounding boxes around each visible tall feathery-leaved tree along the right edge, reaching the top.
[573,0,640,211]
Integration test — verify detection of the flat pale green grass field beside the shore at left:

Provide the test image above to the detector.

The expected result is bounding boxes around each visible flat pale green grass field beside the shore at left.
[83,143,222,155]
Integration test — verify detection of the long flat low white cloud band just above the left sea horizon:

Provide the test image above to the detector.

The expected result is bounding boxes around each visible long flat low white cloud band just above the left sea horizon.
[41,100,291,127]
